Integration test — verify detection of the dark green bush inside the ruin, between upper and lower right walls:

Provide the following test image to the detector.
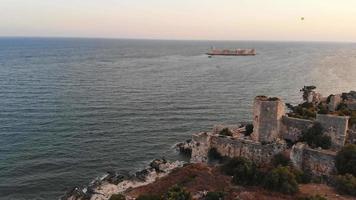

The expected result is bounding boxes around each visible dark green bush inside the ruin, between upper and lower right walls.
[301,123,331,149]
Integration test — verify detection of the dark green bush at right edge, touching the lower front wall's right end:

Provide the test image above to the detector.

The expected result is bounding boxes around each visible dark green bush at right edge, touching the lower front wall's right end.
[335,144,356,176]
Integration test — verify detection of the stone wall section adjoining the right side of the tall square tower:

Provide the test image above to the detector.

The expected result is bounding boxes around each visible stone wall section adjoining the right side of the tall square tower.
[281,116,313,142]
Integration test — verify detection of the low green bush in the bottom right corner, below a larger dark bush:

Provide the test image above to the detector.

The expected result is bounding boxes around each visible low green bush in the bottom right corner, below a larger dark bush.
[336,174,356,196]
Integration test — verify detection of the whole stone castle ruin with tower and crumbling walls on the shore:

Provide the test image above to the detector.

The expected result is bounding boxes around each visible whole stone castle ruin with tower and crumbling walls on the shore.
[181,86,356,176]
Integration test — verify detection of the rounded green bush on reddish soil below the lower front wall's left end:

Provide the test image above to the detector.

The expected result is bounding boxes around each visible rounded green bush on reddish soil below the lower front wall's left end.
[263,167,298,194]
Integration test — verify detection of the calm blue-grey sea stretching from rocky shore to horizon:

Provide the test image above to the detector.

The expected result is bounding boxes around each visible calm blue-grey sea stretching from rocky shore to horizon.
[0,38,356,200]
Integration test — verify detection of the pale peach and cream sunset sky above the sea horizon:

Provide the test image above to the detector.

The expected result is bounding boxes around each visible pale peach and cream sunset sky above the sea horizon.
[0,0,356,42]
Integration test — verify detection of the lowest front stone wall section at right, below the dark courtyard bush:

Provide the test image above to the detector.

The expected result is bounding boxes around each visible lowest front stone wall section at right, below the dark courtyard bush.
[290,143,336,176]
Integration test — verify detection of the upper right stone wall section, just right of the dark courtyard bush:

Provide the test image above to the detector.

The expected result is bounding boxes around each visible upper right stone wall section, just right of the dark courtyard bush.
[316,114,349,148]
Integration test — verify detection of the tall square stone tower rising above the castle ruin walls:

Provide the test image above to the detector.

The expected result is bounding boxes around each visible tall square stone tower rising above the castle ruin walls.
[251,96,285,142]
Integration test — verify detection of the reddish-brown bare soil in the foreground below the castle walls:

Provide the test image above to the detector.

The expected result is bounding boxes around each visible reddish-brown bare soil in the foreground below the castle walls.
[126,164,356,200]
